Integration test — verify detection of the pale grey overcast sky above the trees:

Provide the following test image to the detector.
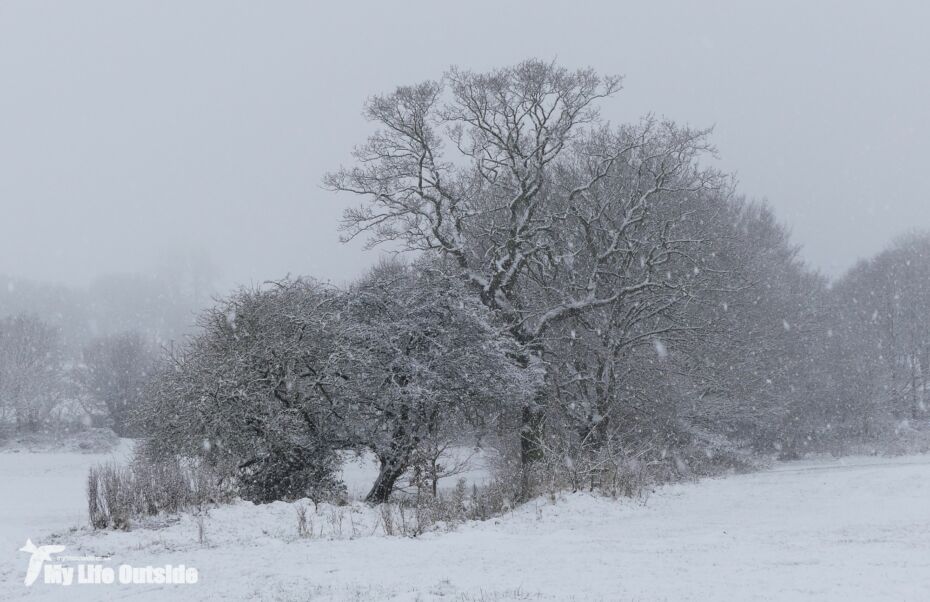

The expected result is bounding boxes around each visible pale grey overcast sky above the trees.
[0,0,930,285]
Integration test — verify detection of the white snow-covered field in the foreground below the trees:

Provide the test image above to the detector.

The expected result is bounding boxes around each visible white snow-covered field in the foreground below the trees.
[0,453,930,601]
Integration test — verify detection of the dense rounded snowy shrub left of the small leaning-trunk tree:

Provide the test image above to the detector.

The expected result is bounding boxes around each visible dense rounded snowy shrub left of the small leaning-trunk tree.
[138,280,352,502]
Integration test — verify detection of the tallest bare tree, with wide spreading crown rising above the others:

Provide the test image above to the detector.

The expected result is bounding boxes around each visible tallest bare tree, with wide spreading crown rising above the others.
[325,60,726,482]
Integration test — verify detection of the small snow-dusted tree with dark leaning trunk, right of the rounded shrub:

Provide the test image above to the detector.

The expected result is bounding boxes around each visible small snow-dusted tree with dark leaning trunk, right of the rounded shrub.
[339,261,535,502]
